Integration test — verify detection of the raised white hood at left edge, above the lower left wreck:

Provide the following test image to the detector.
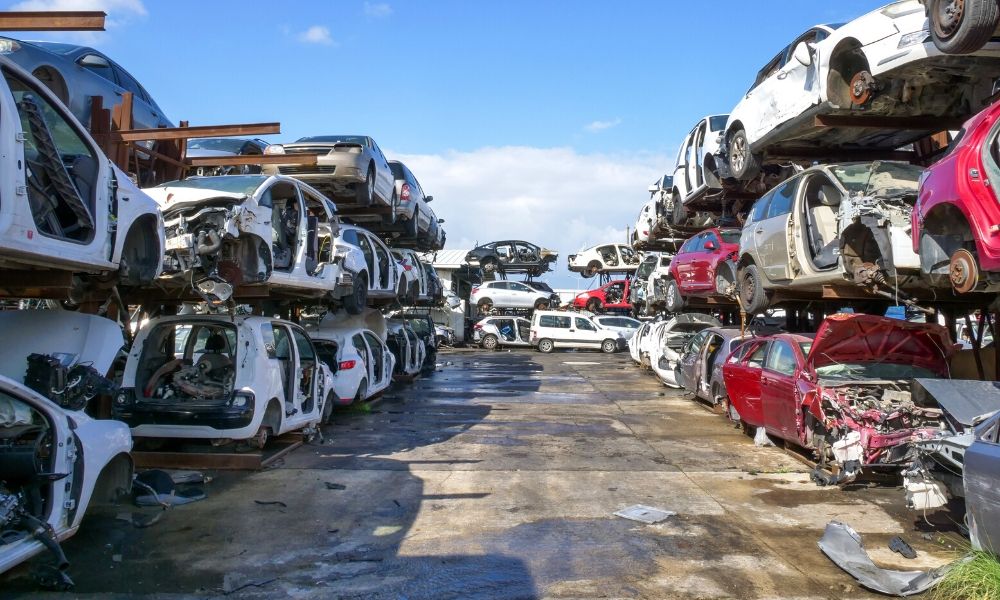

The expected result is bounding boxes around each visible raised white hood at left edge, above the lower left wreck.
[0,310,125,381]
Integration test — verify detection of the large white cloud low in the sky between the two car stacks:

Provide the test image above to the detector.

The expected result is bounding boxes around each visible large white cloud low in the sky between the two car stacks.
[390,146,669,287]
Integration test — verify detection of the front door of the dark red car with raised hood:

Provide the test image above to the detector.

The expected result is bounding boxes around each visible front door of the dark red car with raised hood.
[760,340,798,442]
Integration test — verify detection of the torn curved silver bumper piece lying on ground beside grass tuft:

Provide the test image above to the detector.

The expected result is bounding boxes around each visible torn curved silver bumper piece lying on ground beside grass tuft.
[819,521,956,596]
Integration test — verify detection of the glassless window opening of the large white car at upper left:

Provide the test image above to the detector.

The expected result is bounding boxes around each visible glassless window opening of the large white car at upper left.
[3,69,99,242]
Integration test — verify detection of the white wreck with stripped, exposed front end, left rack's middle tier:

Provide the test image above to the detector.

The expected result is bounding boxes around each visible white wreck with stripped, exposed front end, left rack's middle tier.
[146,175,367,312]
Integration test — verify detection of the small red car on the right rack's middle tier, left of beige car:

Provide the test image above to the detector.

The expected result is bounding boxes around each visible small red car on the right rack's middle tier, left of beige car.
[665,227,741,312]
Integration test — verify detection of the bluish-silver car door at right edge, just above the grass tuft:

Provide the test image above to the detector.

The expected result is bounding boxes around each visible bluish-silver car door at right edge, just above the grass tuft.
[964,417,1000,551]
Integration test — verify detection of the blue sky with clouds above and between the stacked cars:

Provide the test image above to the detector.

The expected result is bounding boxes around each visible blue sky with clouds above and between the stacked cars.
[9,0,883,285]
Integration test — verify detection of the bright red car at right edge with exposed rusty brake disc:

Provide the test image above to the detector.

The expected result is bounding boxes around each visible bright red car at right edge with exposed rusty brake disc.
[911,102,1000,294]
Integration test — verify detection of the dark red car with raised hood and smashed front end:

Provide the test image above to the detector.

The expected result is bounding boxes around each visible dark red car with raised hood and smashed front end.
[722,314,953,484]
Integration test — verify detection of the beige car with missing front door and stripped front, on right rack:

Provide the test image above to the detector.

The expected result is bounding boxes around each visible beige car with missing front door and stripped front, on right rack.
[737,161,925,313]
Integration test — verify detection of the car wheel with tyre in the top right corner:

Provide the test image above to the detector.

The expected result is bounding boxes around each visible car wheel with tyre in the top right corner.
[927,0,1000,54]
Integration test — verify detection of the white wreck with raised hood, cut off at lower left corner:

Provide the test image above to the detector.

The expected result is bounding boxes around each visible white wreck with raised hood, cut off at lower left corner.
[0,310,132,588]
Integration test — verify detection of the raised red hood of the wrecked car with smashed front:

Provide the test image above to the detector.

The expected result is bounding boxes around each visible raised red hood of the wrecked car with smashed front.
[806,314,954,376]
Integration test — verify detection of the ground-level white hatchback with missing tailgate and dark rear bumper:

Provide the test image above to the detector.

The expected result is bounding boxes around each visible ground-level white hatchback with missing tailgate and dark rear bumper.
[113,315,333,448]
